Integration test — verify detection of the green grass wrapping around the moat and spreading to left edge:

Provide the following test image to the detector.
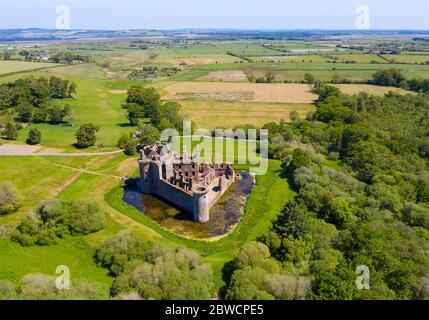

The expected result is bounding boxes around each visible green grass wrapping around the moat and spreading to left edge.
[0,145,294,288]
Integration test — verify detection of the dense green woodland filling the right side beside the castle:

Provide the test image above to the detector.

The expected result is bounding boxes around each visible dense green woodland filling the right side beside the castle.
[237,85,429,300]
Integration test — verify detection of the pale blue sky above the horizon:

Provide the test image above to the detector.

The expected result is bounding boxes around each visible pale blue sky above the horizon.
[0,0,429,30]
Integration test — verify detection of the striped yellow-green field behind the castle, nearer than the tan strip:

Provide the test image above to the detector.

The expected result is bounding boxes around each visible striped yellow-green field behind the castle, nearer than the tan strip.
[175,101,315,130]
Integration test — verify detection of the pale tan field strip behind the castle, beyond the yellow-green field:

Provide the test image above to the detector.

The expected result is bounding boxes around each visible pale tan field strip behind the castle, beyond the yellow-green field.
[164,82,317,103]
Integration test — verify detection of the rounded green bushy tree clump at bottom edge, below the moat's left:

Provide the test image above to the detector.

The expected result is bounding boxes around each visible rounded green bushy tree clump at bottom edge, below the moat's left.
[96,231,214,300]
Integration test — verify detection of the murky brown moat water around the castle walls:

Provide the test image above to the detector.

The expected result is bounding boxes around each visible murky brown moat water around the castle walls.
[123,172,255,239]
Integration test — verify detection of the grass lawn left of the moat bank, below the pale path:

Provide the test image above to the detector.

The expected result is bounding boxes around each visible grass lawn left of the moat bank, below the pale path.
[0,151,137,288]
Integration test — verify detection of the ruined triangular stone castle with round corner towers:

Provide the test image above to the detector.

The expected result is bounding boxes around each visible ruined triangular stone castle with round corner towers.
[139,143,238,223]
